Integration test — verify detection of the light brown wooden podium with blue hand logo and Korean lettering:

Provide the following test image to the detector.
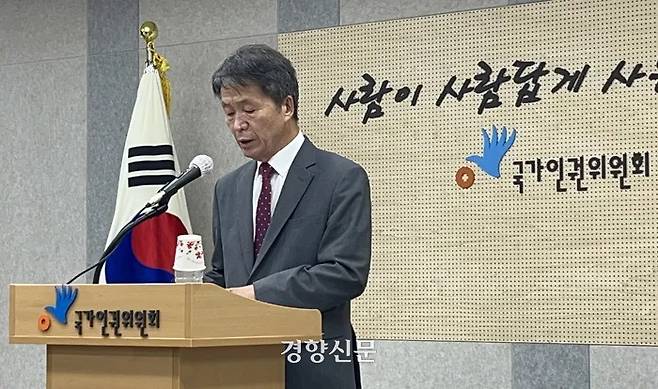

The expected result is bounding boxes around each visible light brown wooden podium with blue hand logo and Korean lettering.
[9,284,322,389]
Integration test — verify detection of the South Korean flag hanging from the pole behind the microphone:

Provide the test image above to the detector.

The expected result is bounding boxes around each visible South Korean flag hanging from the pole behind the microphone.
[100,66,192,283]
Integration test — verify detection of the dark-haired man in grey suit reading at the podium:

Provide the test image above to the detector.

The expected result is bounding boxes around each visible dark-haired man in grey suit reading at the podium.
[205,45,371,389]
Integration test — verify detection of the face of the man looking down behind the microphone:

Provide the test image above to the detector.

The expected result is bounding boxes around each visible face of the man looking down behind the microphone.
[220,85,297,161]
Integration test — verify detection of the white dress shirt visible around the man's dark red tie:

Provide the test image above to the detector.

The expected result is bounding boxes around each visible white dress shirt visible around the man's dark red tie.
[252,131,304,238]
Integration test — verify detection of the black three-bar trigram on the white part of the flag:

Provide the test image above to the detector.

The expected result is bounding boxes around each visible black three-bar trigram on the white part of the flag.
[128,145,176,188]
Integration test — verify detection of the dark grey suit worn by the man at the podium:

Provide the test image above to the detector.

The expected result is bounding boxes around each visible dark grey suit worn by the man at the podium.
[206,139,371,389]
